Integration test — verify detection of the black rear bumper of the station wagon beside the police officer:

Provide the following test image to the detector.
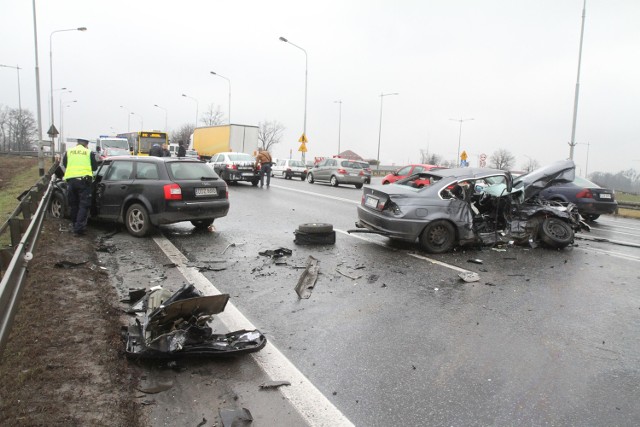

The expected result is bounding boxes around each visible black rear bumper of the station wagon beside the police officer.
[151,199,229,225]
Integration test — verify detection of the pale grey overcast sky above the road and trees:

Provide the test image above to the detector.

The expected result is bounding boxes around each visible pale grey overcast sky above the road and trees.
[0,0,640,174]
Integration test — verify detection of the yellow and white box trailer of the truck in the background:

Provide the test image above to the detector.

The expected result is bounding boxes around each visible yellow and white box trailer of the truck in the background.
[189,125,258,159]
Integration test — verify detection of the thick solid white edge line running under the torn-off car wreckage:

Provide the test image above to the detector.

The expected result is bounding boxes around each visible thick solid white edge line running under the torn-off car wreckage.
[153,237,353,427]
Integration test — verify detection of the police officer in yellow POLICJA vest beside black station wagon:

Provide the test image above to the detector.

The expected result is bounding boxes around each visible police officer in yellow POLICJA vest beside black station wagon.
[62,139,98,236]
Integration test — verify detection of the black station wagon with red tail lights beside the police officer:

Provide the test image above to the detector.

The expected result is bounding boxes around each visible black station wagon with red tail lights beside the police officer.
[50,156,229,237]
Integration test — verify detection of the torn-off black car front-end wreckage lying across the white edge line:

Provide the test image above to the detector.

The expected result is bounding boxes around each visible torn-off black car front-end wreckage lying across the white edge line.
[123,285,267,358]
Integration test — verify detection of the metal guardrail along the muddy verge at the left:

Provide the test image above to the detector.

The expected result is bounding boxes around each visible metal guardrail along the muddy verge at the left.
[0,164,57,355]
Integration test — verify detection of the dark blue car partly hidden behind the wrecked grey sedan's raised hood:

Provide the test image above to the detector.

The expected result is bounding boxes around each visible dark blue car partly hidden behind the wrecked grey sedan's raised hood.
[540,176,618,221]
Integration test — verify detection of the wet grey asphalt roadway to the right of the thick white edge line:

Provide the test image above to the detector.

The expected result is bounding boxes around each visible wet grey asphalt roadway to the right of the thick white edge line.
[104,179,640,426]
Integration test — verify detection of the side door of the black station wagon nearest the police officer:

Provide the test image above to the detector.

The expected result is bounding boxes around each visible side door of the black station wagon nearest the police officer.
[95,160,134,220]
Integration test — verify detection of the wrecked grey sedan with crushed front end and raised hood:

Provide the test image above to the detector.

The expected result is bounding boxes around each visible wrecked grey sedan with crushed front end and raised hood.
[350,160,589,253]
